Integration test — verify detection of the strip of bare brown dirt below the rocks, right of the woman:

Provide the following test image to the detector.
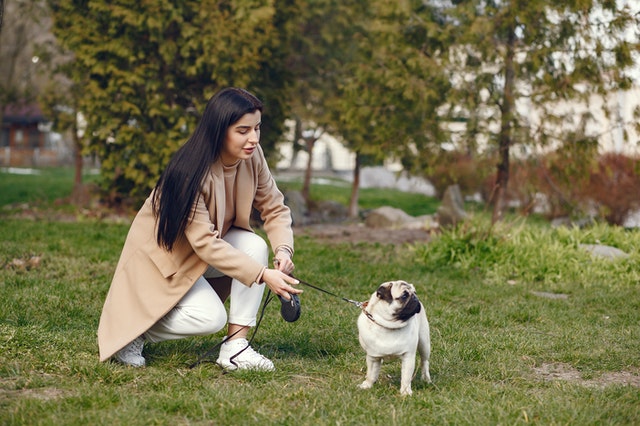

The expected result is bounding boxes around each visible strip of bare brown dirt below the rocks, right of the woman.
[294,223,431,244]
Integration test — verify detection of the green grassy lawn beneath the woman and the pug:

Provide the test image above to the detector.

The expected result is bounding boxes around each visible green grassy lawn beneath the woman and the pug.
[0,168,640,426]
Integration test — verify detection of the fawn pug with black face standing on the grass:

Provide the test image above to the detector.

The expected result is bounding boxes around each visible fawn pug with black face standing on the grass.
[358,281,431,395]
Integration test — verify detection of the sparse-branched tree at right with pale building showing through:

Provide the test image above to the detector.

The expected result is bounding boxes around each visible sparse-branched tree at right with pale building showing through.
[433,0,640,222]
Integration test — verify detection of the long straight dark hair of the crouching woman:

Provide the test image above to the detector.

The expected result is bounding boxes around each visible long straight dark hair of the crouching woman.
[152,87,262,251]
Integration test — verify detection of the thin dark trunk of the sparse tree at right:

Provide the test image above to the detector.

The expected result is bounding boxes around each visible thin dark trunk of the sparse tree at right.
[491,28,515,223]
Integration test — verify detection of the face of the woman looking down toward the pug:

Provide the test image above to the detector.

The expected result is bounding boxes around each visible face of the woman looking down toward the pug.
[220,111,262,165]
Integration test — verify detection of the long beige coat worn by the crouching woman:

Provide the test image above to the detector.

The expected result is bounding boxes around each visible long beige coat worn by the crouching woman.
[98,149,293,361]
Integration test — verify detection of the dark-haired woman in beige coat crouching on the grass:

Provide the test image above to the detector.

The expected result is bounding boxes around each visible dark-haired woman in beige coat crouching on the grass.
[98,88,302,370]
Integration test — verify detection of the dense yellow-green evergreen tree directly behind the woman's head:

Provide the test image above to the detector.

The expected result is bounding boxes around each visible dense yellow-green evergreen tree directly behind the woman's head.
[50,0,295,203]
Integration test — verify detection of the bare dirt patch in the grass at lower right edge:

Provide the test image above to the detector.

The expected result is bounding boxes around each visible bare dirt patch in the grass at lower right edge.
[533,362,640,388]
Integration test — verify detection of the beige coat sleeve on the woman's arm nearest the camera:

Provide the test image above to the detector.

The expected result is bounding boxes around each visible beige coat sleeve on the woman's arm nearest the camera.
[185,186,264,286]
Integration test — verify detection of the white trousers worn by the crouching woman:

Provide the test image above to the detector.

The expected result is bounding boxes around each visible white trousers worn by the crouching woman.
[144,228,269,342]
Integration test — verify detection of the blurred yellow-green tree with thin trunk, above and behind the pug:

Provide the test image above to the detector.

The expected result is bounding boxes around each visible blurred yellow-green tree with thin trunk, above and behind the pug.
[330,0,449,217]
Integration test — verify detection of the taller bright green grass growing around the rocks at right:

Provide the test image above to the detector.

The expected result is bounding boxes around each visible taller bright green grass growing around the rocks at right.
[416,215,640,291]
